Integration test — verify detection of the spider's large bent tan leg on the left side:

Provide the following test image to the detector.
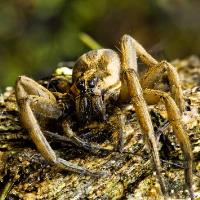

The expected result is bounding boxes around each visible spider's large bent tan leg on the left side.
[15,76,103,176]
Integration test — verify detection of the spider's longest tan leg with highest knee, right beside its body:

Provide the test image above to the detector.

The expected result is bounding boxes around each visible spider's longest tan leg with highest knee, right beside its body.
[120,35,168,198]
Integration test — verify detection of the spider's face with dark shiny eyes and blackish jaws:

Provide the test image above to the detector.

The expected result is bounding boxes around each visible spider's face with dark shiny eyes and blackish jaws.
[73,75,105,123]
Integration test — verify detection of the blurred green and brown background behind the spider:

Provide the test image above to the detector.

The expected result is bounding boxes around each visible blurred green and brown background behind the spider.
[0,0,200,91]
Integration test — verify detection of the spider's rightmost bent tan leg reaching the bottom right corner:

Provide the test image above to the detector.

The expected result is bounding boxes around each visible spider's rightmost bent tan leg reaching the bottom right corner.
[144,89,194,199]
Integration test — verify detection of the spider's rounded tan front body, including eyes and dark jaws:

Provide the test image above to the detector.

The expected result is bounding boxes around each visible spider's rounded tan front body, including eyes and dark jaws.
[72,49,121,122]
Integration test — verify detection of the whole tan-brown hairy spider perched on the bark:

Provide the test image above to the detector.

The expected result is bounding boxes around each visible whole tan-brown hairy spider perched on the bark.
[15,35,193,199]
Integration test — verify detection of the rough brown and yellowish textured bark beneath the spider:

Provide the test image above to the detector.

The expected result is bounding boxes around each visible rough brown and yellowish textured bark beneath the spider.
[0,57,200,199]
